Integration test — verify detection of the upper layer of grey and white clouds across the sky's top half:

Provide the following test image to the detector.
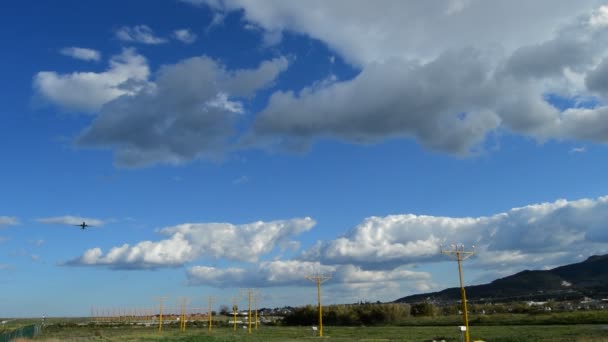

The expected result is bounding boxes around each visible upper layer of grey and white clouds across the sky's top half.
[34,0,608,167]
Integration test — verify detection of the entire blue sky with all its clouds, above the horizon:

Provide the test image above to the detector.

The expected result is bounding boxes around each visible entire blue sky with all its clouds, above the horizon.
[0,0,608,317]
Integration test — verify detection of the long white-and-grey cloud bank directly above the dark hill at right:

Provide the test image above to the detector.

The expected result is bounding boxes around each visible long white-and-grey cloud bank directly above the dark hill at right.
[302,196,608,269]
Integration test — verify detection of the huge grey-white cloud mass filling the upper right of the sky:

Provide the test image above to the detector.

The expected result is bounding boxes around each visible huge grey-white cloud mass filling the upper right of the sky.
[189,0,608,155]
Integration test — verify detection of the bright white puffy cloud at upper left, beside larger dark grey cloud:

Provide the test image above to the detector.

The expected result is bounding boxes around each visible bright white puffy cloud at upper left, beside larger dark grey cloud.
[34,49,150,112]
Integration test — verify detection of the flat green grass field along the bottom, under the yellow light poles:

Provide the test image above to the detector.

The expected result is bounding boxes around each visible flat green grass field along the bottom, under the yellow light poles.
[36,325,608,342]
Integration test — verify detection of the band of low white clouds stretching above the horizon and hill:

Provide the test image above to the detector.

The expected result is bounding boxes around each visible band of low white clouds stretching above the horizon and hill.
[65,196,608,293]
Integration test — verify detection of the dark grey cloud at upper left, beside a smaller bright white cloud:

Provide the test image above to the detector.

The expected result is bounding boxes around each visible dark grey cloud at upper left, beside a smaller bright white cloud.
[76,56,288,167]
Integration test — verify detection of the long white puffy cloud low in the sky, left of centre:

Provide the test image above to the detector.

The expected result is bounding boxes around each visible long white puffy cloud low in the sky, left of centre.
[66,218,315,269]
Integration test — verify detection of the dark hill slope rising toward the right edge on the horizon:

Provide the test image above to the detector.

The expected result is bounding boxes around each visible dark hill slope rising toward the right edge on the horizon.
[395,254,608,303]
